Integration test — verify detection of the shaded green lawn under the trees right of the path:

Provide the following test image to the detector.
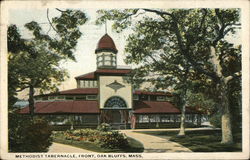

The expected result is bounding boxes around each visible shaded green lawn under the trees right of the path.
[135,130,242,152]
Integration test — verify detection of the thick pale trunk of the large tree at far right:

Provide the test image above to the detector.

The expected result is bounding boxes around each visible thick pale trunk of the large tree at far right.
[221,86,233,144]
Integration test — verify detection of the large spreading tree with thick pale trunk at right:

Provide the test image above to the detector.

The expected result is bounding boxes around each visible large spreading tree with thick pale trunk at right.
[97,8,241,143]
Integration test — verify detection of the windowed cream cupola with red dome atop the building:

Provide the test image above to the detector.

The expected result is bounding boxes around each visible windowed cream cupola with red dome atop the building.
[95,33,118,69]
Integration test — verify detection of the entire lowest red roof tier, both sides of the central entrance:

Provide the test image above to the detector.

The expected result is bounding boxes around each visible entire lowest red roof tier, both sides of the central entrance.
[19,100,202,114]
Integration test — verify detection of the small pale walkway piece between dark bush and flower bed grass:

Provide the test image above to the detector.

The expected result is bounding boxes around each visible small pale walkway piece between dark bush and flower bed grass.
[48,142,93,153]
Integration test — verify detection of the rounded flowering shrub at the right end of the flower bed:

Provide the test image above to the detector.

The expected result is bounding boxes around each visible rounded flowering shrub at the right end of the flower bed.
[98,131,128,149]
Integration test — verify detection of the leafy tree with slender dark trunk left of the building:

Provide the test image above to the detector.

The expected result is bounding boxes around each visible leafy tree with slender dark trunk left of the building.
[8,9,87,115]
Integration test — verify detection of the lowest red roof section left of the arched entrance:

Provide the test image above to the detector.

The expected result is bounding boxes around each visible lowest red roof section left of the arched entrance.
[19,101,100,114]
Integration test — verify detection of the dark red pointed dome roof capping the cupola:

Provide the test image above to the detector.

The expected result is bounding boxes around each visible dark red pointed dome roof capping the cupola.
[95,33,118,53]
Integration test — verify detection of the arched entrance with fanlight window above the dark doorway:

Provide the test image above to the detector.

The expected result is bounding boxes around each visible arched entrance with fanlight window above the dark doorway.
[101,96,129,129]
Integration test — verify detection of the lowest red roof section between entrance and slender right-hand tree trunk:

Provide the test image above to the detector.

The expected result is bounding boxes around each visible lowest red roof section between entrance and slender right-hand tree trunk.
[134,101,181,114]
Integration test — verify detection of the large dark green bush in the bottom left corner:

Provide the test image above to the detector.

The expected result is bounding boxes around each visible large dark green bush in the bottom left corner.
[8,113,52,152]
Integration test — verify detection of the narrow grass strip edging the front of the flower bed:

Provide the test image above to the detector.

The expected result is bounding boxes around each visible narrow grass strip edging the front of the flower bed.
[53,132,144,153]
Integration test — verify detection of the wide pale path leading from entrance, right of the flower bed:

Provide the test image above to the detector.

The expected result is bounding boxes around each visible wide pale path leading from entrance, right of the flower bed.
[121,130,192,153]
